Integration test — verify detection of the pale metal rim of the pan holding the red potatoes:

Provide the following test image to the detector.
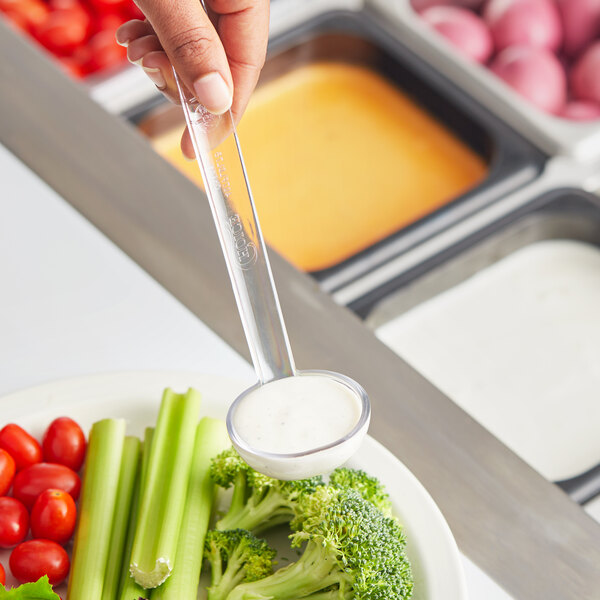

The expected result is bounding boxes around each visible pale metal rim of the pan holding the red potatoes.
[368,0,600,162]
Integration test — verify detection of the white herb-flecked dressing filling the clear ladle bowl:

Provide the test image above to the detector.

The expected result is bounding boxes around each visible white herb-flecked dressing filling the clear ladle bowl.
[233,375,361,454]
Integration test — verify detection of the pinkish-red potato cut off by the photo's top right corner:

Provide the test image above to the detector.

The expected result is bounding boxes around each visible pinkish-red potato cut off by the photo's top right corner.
[556,0,600,57]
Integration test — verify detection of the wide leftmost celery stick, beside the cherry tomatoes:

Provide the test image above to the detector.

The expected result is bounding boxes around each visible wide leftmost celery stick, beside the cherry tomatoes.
[68,419,125,600]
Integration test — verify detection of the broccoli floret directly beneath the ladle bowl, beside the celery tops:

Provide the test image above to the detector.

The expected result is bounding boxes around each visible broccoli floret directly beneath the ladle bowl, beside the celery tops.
[210,448,324,534]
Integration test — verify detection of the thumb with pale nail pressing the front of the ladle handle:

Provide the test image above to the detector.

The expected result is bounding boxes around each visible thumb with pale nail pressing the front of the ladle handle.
[136,0,233,114]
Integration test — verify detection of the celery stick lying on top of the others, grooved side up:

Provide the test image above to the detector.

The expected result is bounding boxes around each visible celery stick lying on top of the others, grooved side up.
[130,389,200,589]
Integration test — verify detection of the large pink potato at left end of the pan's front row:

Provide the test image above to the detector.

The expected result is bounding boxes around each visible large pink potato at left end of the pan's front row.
[421,6,494,63]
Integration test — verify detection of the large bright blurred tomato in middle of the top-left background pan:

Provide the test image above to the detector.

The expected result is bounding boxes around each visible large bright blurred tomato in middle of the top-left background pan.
[32,7,91,56]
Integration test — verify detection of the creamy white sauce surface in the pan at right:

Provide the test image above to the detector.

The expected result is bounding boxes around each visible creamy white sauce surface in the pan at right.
[377,240,600,480]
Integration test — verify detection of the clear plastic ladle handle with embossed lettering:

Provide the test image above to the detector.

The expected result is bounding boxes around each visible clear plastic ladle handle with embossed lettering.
[175,73,295,383]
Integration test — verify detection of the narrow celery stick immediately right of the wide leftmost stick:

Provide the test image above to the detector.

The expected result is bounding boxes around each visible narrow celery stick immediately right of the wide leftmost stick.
[102,436,140,600]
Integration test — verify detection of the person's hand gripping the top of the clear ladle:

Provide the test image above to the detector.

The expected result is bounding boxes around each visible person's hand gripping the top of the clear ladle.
[116,0,269,158]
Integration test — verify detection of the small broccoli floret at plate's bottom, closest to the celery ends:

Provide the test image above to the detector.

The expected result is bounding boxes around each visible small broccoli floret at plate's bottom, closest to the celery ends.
[204,529,275,600]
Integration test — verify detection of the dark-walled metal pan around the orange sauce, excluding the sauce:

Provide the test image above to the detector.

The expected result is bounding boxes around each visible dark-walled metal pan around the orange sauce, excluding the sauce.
[129,10,545,290]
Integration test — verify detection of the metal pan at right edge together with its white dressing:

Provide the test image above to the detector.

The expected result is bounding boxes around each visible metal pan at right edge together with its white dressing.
[363,189,600,500]
